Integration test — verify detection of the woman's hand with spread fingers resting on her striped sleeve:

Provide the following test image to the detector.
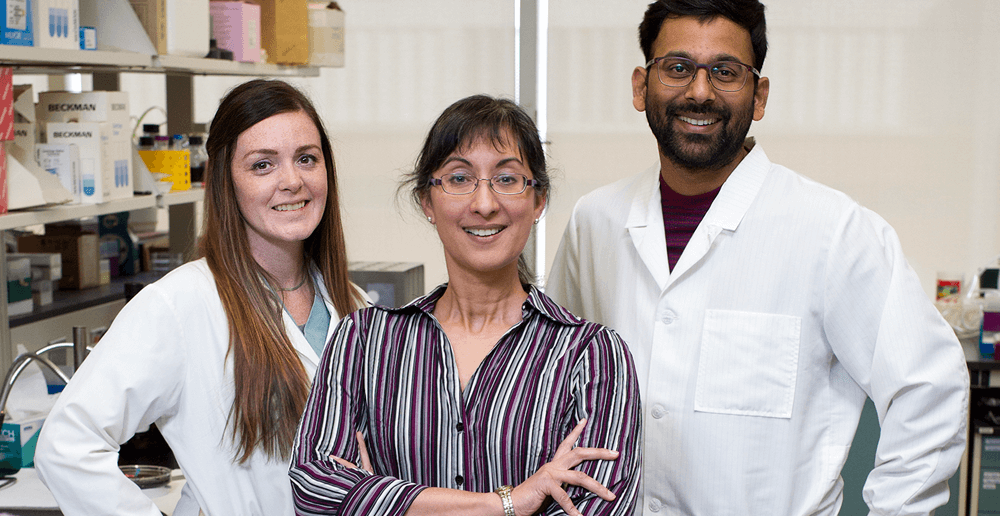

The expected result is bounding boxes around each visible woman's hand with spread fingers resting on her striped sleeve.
[511,419,618,516]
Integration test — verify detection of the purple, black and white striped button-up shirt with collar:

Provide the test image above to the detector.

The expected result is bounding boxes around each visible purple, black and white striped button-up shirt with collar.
[289,285,641,515]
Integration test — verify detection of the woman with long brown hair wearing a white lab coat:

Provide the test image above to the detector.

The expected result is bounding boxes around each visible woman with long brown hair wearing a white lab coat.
[35,80,365,515]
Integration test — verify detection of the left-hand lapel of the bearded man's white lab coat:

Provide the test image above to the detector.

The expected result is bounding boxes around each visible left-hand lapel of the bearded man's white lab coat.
[625,163,670,291]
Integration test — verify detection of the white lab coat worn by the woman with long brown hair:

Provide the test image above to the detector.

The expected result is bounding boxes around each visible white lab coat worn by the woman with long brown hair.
[35,259,356,516]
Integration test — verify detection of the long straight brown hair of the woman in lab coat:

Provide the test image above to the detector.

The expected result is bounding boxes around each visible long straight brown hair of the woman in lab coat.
[201,80,363,463]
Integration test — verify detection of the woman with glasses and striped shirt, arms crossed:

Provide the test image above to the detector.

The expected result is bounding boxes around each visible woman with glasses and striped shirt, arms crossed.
[290,95,640,516]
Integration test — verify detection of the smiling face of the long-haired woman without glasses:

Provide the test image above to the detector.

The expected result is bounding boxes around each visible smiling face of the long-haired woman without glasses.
[232,111,327,257]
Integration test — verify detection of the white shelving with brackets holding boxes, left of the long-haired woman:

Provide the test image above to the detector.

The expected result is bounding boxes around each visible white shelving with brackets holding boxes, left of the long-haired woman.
[0,45,319,374]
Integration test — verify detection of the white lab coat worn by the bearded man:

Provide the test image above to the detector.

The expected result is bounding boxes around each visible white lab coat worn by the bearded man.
[547,145,969,516]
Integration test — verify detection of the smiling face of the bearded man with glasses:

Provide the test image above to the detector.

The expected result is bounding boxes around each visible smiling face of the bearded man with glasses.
[632,16,769,176]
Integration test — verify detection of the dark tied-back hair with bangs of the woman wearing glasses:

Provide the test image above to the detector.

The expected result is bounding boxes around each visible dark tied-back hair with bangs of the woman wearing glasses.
[400,95,550,285]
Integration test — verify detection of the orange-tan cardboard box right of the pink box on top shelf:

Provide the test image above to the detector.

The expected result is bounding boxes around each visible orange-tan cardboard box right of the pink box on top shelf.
[252,0,309,65]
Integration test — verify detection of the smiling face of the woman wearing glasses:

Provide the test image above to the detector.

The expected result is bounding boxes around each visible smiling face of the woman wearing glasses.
[421,134,545,281]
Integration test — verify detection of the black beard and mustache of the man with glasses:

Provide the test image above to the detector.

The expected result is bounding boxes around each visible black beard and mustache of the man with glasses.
[646,96,753,170]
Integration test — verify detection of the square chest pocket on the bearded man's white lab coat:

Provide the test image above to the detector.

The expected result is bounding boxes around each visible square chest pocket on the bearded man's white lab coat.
[694,310,802,418]
